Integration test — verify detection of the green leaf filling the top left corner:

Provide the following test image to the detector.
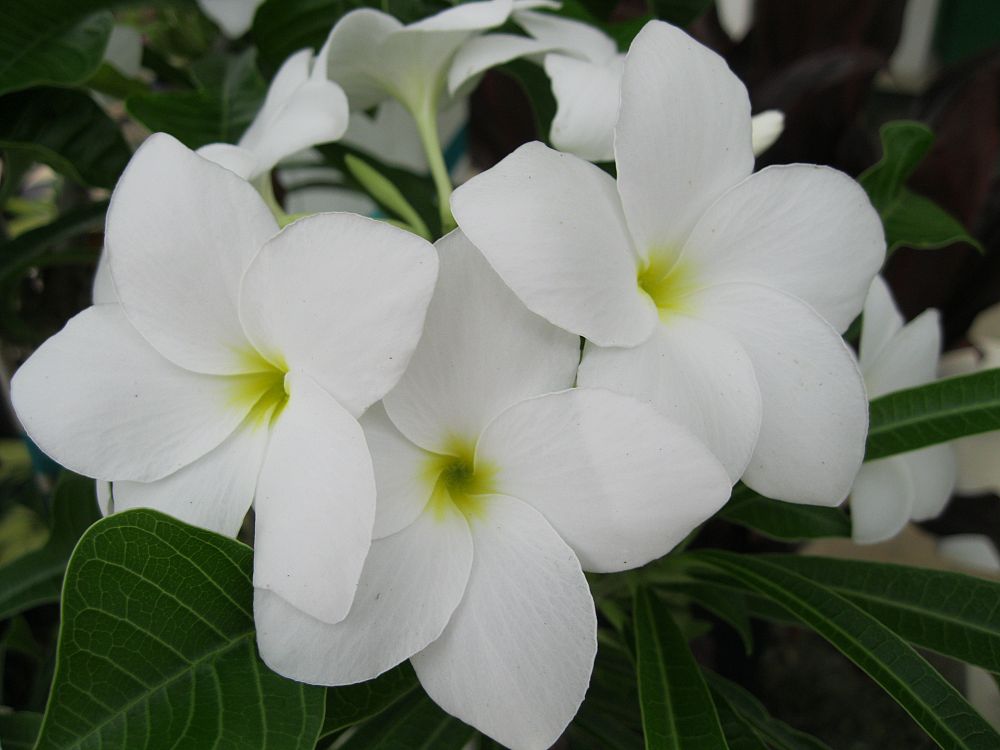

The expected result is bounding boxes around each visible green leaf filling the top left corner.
[0,0,114,94]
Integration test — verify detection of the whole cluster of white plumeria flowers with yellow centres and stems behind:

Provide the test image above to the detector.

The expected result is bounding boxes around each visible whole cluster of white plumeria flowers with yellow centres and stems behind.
[13,5,900,750]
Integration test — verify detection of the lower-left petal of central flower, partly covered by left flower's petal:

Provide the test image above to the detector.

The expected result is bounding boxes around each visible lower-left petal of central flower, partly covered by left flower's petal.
[254,508,473,685]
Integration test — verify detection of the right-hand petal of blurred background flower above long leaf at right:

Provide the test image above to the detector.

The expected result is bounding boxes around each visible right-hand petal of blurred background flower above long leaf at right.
[864,310,941,398]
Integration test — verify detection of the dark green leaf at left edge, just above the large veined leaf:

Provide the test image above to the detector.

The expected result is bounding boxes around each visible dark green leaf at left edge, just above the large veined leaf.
[0,473,101,620]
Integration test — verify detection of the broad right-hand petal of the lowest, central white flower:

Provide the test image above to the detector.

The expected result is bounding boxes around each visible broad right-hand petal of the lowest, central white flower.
[476,388,732,573]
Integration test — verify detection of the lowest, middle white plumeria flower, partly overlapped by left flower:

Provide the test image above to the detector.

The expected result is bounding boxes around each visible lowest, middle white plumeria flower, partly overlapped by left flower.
[254,232,729,750]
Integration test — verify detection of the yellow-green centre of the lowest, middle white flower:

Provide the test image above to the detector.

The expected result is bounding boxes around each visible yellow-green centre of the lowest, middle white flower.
[424,440,497,518]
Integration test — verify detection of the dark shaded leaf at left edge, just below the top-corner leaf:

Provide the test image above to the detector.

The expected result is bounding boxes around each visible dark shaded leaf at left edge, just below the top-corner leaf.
[0,88,132,188]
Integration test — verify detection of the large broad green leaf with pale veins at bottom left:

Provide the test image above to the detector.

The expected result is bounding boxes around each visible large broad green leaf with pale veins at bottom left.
[37,510,324,750]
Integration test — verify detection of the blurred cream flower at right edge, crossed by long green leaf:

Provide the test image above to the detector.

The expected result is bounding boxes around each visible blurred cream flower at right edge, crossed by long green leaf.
[940,305,1000,495]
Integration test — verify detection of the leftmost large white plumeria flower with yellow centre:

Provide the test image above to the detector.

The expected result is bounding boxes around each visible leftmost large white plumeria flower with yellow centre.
[12,134,437,622]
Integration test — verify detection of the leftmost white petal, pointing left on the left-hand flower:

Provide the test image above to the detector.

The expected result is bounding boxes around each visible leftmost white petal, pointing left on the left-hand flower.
[11,305,250,482]
